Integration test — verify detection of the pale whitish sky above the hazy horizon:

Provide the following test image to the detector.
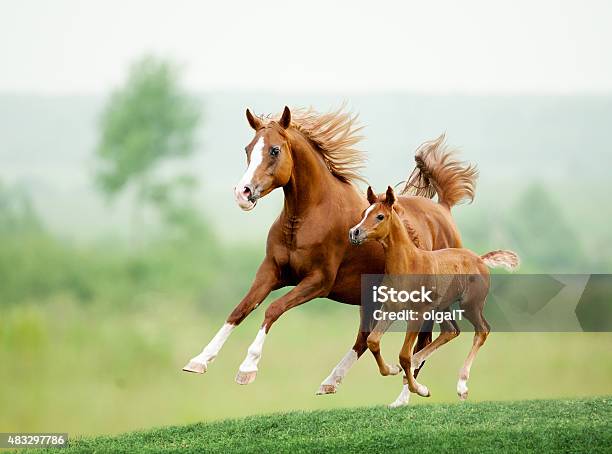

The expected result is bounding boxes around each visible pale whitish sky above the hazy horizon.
[0,0,612,94]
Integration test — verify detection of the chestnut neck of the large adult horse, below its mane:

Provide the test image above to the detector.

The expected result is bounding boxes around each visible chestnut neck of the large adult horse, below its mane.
[283,132,335,220]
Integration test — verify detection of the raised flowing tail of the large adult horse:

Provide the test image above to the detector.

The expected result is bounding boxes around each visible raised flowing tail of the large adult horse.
[401,134,478,209]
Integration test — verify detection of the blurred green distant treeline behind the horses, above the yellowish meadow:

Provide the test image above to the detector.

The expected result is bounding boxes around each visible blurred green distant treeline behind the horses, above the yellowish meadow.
[0,177,612,311]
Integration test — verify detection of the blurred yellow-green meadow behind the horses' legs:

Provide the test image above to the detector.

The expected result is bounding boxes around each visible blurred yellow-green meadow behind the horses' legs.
[0,296,612,434]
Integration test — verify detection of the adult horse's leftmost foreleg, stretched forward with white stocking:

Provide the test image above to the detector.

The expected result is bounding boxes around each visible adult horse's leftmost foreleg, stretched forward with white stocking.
[183,258,279,374]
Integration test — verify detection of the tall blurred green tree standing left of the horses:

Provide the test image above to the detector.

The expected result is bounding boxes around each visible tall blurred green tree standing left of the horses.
[96,56,200,234]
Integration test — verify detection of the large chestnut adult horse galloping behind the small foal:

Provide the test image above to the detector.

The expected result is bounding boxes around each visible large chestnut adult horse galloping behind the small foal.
[183,107,476,394]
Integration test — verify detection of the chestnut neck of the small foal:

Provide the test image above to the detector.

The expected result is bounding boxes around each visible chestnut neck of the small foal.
[381,211,422,274]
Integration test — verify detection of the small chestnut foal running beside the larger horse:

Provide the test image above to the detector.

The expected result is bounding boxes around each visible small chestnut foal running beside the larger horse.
[349,186,519,407]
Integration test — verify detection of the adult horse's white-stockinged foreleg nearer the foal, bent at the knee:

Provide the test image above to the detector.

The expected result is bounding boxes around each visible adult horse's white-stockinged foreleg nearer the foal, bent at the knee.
[236,275,330,385]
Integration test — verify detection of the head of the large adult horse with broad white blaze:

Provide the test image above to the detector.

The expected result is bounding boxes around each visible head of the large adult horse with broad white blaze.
[234,107,293,211]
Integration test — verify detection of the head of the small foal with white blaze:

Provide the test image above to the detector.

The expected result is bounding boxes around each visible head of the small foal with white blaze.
[349,186,395,245]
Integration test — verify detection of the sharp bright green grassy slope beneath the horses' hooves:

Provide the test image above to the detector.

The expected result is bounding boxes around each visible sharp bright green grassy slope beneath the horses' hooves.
[37,397,612,453]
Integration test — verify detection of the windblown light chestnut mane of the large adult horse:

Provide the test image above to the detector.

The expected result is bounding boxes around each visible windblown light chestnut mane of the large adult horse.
[262,105,367,183]
